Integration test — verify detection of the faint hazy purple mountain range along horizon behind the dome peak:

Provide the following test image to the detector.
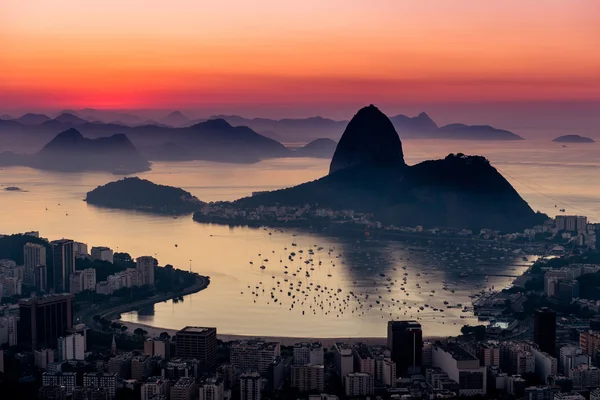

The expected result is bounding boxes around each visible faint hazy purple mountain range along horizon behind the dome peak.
[0,108,523,148]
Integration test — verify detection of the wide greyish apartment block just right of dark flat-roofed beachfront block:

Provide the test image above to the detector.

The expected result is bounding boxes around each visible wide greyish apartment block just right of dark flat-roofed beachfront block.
[229,340,281,375]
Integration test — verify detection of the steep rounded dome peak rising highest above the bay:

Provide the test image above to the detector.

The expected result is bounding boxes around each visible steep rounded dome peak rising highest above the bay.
[329,104,406,174]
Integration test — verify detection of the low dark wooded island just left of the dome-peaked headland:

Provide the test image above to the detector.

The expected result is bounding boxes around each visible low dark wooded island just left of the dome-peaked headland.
[85,177,204,215]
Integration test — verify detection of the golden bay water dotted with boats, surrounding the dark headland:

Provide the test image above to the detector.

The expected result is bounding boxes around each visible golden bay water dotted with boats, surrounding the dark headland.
[0,140,600,337]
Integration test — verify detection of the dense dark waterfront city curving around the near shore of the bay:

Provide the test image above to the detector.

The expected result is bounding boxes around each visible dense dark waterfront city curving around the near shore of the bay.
[0,212,600,400]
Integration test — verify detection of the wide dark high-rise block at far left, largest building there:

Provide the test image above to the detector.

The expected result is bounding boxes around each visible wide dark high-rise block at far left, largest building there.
[18,294,73,350]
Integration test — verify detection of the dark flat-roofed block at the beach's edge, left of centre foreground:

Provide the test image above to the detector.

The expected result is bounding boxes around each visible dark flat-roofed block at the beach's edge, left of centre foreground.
[175,326,217,369]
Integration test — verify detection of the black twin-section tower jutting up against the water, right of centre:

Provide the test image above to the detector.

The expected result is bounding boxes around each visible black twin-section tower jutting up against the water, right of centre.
[387,321,423,376]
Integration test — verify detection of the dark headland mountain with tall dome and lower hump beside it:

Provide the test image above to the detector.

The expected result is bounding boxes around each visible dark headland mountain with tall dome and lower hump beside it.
[234,105,548,232]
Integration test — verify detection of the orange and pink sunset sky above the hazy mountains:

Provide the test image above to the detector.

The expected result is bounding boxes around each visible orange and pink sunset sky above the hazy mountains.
[0,0,600,122]
